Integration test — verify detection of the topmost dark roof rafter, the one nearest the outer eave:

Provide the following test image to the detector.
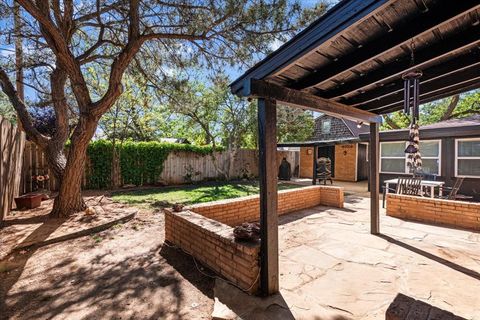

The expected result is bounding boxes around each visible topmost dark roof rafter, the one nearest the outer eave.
[291,0,480,90]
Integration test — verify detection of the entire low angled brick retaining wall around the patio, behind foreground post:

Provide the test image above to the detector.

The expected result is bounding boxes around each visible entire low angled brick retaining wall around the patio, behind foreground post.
[165,186,344,293]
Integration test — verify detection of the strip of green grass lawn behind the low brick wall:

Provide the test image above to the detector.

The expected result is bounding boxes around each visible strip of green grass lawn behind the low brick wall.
[112,182,301,208]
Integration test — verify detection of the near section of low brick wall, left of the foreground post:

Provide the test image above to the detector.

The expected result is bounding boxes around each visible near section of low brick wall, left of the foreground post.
[165,210,260,293]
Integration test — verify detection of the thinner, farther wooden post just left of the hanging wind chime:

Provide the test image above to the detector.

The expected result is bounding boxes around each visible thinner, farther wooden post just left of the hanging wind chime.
[369,122,380,234]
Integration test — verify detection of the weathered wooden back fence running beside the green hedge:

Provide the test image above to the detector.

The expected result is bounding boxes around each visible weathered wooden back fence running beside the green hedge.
[21,142,298,193]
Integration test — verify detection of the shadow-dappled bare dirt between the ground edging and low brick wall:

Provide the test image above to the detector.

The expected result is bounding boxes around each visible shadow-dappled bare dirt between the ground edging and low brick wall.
[0,201,214,319]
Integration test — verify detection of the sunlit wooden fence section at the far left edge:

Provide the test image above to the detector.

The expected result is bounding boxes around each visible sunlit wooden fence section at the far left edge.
[0,117,25,224]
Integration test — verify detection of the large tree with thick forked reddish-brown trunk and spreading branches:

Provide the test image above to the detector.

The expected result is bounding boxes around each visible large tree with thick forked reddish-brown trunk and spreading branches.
[0,0,324,217]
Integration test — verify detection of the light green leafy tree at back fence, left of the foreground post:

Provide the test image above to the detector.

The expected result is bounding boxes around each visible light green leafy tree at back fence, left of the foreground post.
[167,76,255,180]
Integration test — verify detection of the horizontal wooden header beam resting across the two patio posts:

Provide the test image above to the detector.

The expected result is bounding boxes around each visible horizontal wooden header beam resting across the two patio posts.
[242,79,382,123]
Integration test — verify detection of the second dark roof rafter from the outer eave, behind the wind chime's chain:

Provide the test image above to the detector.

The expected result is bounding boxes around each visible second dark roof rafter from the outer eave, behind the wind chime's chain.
[322,25,480,99]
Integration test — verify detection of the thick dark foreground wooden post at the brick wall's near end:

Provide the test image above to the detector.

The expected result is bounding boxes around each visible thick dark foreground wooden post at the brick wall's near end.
[258,98,279,296]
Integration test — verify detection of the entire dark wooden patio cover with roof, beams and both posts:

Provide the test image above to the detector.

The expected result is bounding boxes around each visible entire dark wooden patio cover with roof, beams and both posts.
[231,0,480,295]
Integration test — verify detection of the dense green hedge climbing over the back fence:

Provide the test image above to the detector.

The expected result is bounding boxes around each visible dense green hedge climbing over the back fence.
[87,140,217,189]
